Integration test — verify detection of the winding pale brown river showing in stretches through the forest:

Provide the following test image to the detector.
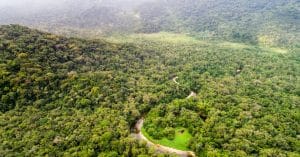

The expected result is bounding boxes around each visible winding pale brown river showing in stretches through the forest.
[132,77,197,157]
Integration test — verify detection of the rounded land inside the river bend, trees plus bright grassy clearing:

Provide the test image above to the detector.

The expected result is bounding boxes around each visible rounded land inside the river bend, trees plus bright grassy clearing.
[144,100,197,150]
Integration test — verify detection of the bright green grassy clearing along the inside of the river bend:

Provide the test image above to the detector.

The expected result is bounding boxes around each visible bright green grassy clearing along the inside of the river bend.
[142,128,192,151]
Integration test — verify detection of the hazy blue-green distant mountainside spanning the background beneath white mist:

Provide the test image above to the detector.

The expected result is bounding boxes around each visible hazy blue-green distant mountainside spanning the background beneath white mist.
[0,0,300,46]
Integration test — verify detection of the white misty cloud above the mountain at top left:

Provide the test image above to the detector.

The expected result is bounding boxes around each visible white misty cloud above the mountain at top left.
[0,0,155,19]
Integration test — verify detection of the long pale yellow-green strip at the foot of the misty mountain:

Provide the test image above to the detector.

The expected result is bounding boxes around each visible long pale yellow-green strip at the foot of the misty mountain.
[106,32,289,56]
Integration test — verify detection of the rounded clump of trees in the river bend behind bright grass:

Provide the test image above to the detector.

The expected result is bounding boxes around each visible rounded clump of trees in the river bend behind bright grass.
[144,99,208,140]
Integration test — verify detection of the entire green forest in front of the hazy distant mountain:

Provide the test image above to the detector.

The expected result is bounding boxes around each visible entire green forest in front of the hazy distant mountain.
[0,25,300,157]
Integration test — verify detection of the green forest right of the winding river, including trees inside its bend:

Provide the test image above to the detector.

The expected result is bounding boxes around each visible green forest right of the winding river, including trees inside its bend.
[129,33,300,156]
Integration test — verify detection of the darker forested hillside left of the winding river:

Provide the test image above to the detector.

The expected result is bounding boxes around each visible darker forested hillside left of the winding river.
[0,25,181,157]
